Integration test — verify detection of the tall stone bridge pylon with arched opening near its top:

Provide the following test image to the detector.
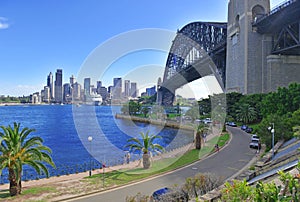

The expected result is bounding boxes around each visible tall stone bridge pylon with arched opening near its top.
[226,0,271,94]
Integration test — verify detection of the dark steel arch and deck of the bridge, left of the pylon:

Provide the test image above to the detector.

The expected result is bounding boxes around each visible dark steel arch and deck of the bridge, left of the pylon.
[157,22,227,106]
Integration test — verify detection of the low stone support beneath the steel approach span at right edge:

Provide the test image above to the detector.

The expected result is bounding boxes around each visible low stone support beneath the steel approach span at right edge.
[264,55,300,92]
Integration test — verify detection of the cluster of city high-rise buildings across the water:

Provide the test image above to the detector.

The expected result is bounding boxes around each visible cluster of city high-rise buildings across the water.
[30,69,142,104]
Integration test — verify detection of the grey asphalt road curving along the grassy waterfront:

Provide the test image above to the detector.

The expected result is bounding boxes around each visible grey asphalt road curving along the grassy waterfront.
[68,127,256,202]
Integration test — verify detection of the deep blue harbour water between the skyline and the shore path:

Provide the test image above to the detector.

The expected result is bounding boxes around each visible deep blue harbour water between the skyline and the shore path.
[0,105,193,183]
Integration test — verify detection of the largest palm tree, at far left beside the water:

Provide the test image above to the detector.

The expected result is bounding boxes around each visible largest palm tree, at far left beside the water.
[0,122,55,196]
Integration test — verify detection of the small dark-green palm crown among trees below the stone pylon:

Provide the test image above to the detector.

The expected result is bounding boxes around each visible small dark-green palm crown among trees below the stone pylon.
[236,103,257,124]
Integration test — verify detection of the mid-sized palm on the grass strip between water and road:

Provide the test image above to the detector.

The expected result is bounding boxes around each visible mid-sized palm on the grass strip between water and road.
[125,131,164,169]
